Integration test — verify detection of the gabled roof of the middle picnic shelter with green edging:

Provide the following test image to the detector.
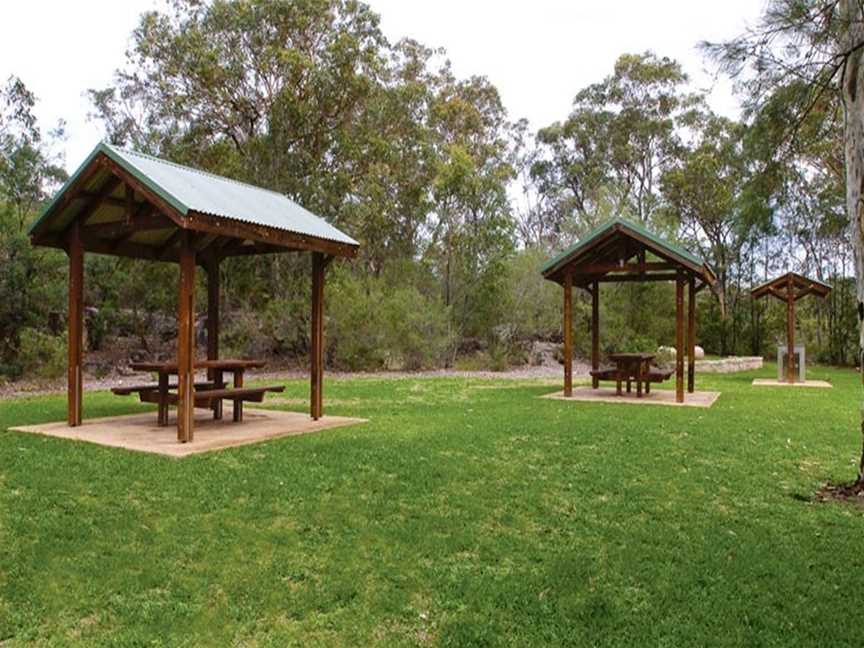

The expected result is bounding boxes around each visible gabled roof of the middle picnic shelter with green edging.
[541,218,715,283]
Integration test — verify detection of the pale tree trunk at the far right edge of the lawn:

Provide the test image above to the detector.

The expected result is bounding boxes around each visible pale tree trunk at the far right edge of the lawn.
[840,0,864,483]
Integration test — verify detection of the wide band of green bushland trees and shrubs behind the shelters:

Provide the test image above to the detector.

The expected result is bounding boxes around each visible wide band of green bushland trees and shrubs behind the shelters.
[0,0,856,375]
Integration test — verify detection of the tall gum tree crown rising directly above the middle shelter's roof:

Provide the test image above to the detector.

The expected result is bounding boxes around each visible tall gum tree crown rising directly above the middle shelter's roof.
[532,52,702,246]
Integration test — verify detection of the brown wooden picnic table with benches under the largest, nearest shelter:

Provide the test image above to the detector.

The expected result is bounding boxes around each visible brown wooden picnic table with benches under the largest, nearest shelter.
[111,359,285,425]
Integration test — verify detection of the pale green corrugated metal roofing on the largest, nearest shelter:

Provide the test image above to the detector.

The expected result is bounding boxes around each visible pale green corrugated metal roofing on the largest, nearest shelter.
[30,142,358,246]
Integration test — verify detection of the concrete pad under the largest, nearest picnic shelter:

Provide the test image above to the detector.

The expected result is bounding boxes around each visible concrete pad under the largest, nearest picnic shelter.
[10,402,366,457]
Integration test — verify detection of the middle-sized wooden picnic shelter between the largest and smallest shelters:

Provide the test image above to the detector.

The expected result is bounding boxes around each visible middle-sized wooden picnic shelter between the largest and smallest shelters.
[541,218,716,403]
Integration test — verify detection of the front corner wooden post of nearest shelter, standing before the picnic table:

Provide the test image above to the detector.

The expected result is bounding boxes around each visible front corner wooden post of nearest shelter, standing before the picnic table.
[177,231,195,443]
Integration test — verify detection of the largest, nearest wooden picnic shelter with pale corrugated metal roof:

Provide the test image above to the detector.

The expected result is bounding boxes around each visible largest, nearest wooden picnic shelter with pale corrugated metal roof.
[29,143,358,442]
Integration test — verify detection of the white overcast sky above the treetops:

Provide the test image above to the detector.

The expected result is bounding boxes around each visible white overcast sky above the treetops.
[0,0,764,171]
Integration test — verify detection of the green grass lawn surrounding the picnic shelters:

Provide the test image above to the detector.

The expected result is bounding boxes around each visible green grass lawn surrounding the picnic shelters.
[0,365,864,648]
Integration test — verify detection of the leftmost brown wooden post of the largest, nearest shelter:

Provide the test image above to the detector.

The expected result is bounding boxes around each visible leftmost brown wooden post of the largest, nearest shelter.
[66,221,84,427]
